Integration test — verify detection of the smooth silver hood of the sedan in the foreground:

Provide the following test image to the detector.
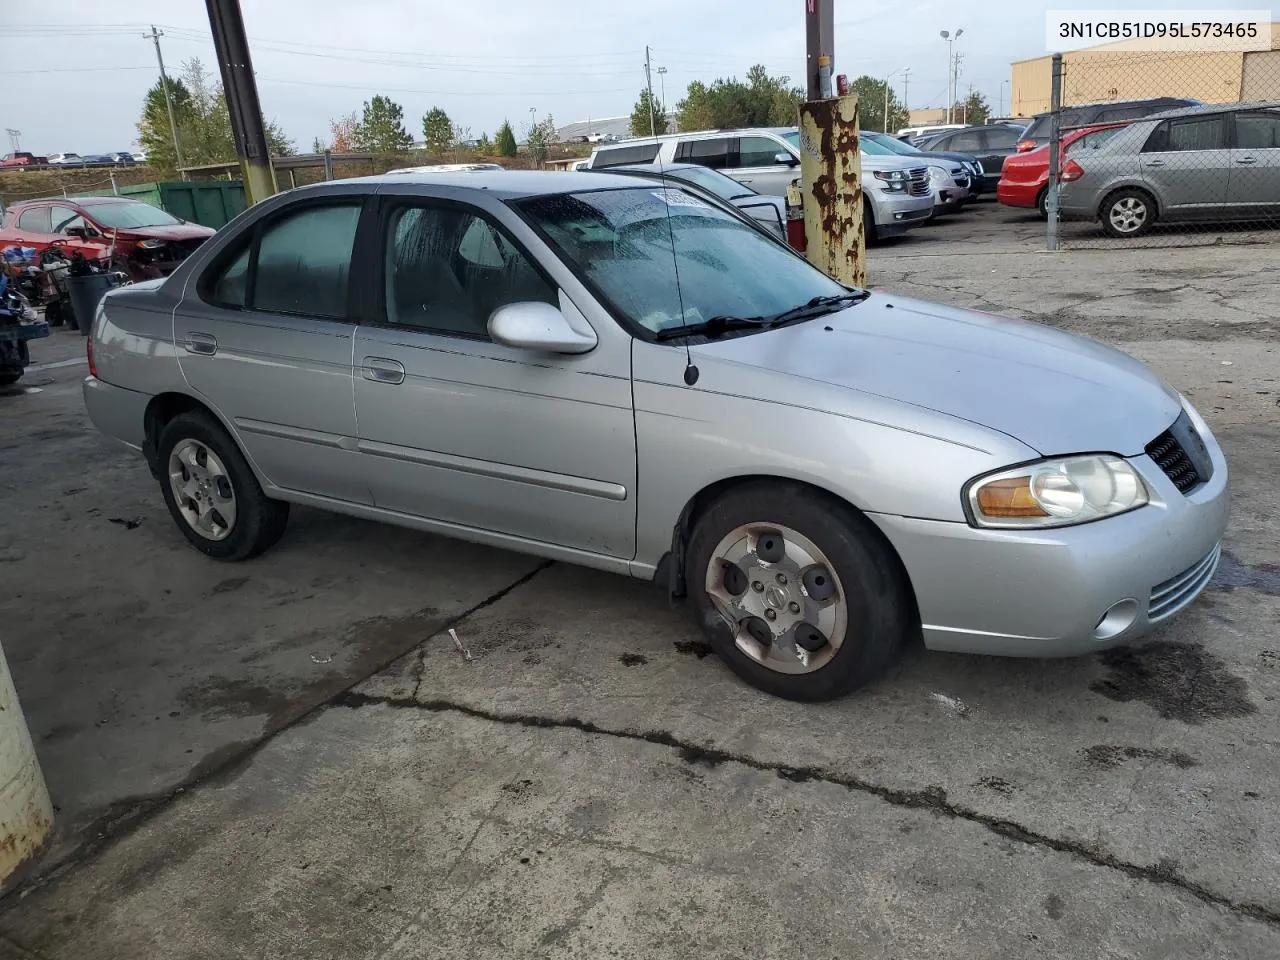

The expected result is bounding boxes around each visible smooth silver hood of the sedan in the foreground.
[698,294,1181,457]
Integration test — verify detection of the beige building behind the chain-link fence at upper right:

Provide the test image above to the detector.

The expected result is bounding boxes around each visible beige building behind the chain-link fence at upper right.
[1010,23,1280,116]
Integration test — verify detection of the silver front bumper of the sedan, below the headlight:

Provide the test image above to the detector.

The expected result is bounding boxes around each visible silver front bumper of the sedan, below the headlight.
[872,417,1230,657]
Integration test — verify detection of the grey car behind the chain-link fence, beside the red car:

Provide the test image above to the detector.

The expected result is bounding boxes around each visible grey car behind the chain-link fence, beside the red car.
[1059,102,1280,237]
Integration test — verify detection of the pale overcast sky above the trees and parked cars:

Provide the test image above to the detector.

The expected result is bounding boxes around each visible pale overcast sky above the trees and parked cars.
[0,0,1240,154]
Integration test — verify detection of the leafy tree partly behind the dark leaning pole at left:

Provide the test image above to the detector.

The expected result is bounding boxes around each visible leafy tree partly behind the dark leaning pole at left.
[138,59,293,172]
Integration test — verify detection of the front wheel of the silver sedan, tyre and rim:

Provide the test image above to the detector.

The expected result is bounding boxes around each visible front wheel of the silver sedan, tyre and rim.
[686,484,911,701]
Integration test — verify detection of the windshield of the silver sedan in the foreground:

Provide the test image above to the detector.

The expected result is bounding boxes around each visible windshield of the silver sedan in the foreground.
[516,184,847,333]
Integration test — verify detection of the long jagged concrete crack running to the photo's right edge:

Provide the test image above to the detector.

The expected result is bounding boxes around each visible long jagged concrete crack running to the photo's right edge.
[330,690,1280,927]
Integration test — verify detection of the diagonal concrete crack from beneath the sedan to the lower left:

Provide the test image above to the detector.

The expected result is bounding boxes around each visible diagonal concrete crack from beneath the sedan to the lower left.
[0,561,556,909]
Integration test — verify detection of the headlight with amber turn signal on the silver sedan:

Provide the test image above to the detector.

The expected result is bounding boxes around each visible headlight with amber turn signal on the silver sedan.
[965,453,1147,527]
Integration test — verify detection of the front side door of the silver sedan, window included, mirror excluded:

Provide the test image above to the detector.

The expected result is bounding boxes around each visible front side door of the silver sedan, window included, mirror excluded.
[355,196,636,558]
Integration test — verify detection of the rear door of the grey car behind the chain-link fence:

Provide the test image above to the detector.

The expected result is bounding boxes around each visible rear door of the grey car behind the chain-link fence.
[1139,114,1231,218]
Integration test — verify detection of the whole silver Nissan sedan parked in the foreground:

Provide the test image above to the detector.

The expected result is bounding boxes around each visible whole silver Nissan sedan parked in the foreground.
[84,172,1228,700]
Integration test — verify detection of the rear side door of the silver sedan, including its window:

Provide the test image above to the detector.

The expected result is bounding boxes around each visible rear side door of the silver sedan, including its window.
[174,197,370,503]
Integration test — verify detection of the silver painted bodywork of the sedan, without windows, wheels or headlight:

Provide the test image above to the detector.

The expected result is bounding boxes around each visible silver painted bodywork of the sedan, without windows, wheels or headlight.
[84,173,1229,655]
